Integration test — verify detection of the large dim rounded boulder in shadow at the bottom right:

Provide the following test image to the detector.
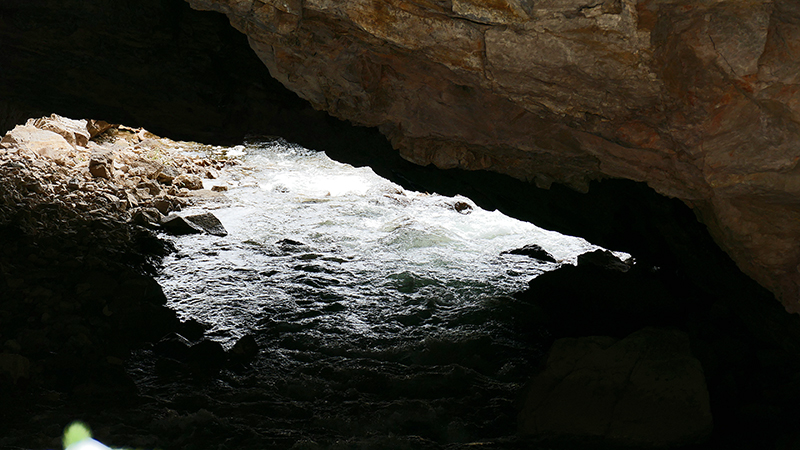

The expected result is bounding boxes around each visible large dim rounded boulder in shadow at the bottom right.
[519,328,712,447]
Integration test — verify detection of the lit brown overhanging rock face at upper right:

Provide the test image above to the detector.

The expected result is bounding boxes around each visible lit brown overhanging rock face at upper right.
[187,0,800,312]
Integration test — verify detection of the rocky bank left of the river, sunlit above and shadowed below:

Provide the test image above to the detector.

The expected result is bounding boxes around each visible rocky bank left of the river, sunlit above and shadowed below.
[0,115,227,448]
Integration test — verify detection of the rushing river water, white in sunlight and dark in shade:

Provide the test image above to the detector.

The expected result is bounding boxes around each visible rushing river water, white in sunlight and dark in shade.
[134,141,608,448]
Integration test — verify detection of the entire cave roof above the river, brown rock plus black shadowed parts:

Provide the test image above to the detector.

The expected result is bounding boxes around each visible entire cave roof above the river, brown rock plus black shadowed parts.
[0,0,798,310]
